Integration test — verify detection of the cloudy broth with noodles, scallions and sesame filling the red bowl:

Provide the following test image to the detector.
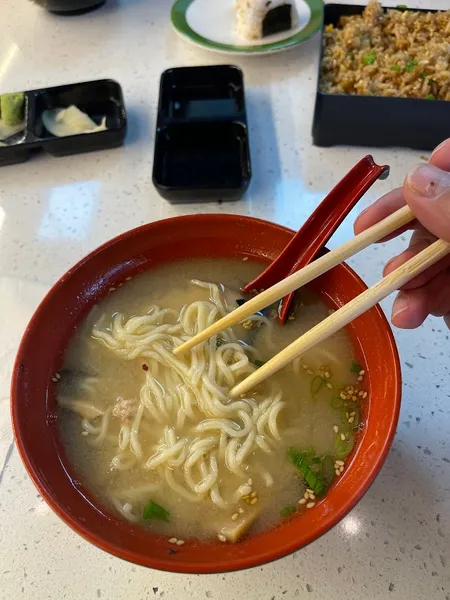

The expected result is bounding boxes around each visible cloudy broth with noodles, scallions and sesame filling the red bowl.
[56,260,366,545]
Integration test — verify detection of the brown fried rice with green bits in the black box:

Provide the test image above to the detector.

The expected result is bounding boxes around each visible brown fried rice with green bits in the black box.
[320,0,450,100]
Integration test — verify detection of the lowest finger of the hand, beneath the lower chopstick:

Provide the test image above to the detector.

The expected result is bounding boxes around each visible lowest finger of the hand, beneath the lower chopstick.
[391,270,450,329]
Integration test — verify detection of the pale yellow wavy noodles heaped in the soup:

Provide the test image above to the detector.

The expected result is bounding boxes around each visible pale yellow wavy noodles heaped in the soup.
[83,280,284,510]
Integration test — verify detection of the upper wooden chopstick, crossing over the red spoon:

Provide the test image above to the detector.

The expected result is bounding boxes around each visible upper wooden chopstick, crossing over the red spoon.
[173,206,414,355]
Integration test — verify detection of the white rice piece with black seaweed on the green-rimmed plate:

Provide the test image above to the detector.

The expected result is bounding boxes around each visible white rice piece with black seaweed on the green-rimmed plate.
[236,0,297,40]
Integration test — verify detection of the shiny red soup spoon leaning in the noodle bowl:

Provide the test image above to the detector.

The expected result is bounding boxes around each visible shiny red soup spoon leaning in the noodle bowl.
[242,154,389,324]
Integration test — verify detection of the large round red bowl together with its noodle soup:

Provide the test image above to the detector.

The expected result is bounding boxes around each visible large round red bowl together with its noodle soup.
[12,215,401,573]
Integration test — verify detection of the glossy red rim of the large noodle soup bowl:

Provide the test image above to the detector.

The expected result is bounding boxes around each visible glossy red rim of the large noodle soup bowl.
[11,213,402,574]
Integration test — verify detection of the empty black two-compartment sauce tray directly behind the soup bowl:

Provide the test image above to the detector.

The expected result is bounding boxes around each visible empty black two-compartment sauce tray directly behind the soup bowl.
[153,65,251,202]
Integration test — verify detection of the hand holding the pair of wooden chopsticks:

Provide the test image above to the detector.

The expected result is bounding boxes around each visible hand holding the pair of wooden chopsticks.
[354,138,450,329]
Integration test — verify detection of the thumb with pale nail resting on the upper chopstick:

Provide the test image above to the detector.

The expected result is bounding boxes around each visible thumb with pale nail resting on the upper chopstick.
[403,163,450,242]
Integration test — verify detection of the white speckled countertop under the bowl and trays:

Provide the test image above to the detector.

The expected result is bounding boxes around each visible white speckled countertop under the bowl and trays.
[0,0,450,600]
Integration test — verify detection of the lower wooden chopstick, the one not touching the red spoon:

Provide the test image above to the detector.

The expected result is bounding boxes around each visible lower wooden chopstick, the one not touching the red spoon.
[230,240,450,398]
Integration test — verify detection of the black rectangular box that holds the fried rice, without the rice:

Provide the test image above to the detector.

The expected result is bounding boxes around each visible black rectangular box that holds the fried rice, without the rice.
[312,4,450,150]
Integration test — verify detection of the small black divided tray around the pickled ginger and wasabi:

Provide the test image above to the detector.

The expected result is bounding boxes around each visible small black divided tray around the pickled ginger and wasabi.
[0,79,127,165]
